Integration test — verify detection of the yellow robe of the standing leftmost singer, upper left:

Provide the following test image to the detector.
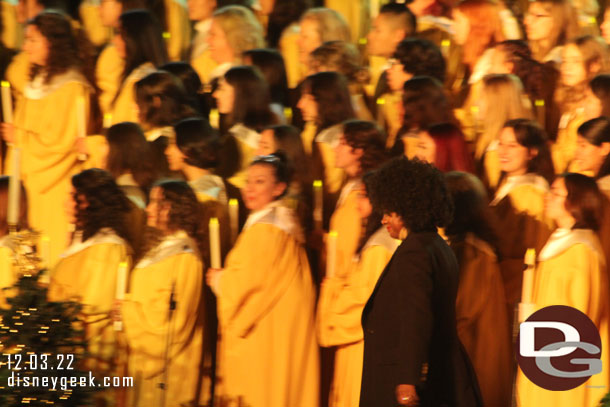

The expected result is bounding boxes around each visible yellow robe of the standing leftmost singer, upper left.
[7,70,93,264]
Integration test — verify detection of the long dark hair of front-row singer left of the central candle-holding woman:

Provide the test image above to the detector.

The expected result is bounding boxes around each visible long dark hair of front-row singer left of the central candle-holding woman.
[154,180,206,255]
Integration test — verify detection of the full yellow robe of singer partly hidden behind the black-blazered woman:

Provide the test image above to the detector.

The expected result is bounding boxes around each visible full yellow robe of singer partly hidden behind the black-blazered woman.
[316,227,400,407]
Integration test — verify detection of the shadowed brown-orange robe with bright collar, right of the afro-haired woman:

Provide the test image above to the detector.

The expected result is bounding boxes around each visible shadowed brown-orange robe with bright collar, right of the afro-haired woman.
[491,174,552,315]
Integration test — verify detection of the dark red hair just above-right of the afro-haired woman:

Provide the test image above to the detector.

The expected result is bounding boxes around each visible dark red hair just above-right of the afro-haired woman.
[425,123,474,173]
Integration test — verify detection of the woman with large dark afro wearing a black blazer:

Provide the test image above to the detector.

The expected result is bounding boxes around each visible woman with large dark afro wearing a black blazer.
[360,158,481,407]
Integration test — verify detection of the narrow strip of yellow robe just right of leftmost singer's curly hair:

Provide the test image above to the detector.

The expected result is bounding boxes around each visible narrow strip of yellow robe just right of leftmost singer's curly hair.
[95,45,125,114]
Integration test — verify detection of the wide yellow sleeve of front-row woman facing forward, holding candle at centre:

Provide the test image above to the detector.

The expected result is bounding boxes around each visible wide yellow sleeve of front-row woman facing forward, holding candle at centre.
[217,223,309,337]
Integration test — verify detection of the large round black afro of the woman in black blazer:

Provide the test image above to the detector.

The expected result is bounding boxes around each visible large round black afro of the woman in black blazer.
[368,157,453,233]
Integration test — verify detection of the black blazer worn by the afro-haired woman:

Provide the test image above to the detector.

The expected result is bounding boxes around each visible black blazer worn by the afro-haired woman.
[360,232,481,407]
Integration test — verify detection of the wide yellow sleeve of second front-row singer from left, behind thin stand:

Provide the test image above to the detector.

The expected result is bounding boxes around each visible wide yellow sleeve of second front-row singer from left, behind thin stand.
[121,253,203,358]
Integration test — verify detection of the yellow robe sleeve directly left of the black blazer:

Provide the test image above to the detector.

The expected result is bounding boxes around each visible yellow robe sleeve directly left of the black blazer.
[317,246,392,347]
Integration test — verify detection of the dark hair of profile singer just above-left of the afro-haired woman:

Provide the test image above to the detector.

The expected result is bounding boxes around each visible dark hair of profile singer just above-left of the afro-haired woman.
[343,120,387,174]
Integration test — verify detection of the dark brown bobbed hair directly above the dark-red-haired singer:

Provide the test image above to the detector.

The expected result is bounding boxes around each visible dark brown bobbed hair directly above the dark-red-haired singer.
[402,76,455,130]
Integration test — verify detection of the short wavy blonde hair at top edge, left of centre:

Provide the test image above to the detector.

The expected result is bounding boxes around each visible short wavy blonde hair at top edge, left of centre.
[213,6,265,62]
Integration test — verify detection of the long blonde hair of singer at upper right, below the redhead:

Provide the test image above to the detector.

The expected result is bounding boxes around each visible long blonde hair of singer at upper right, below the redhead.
[475,74,534,158]
